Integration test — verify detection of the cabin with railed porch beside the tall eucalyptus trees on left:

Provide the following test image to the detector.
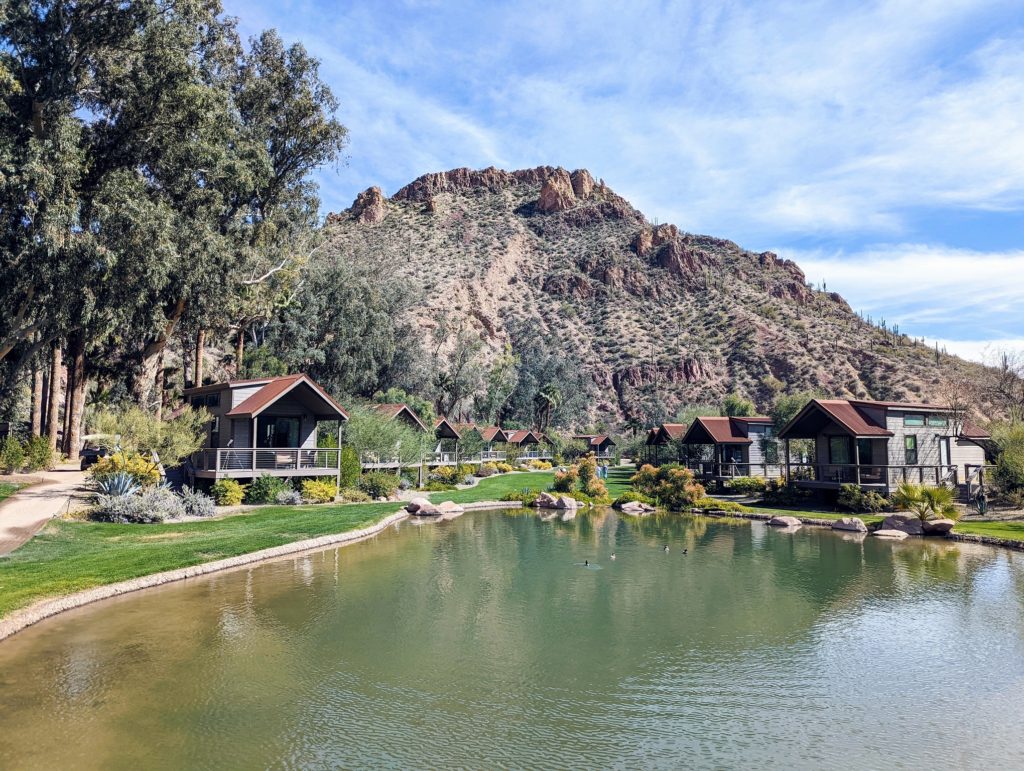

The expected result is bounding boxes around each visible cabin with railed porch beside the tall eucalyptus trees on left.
[190,375,348,479]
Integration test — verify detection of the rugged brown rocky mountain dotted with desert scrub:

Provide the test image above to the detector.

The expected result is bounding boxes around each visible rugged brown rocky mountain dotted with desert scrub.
[328,167,976,423]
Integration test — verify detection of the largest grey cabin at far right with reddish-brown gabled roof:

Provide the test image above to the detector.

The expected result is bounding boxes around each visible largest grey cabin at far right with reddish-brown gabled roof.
[778,399,990,494]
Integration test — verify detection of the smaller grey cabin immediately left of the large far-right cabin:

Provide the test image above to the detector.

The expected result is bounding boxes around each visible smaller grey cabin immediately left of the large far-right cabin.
[681,416,782,482]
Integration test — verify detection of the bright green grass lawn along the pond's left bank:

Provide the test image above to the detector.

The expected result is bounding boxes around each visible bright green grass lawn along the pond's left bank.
[0,471,554,616]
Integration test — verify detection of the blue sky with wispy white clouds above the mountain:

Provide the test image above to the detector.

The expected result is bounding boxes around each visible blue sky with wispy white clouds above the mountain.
[225,0,1024,359]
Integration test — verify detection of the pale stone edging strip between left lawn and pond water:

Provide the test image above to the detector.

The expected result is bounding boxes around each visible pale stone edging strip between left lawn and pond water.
[0,501,522,641]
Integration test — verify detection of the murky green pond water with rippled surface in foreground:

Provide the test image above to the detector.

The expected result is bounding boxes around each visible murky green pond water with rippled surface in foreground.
[0,512,1024,769]
